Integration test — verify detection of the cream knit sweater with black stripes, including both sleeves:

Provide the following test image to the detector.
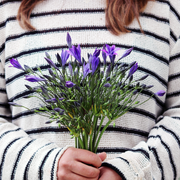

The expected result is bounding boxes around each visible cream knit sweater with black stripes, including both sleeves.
[0,0,180,180]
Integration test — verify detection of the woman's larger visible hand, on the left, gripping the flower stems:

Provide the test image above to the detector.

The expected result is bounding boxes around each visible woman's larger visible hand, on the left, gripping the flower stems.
[57,148,106,180]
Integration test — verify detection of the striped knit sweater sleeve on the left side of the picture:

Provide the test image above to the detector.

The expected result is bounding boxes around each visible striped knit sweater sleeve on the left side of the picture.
[0,1,67,180]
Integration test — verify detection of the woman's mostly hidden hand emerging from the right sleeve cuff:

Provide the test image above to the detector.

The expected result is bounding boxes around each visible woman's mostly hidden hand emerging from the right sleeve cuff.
[99,166,122,180]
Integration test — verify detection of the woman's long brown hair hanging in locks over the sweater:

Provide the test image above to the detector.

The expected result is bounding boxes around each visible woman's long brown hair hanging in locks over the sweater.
[17,0,153,35]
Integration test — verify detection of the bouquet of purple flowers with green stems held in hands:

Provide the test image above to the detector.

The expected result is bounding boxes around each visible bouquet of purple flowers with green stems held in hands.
[9,33,165,153]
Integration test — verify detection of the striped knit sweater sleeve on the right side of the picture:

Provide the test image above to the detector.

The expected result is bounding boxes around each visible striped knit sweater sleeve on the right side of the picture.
[103,0,180,180]
